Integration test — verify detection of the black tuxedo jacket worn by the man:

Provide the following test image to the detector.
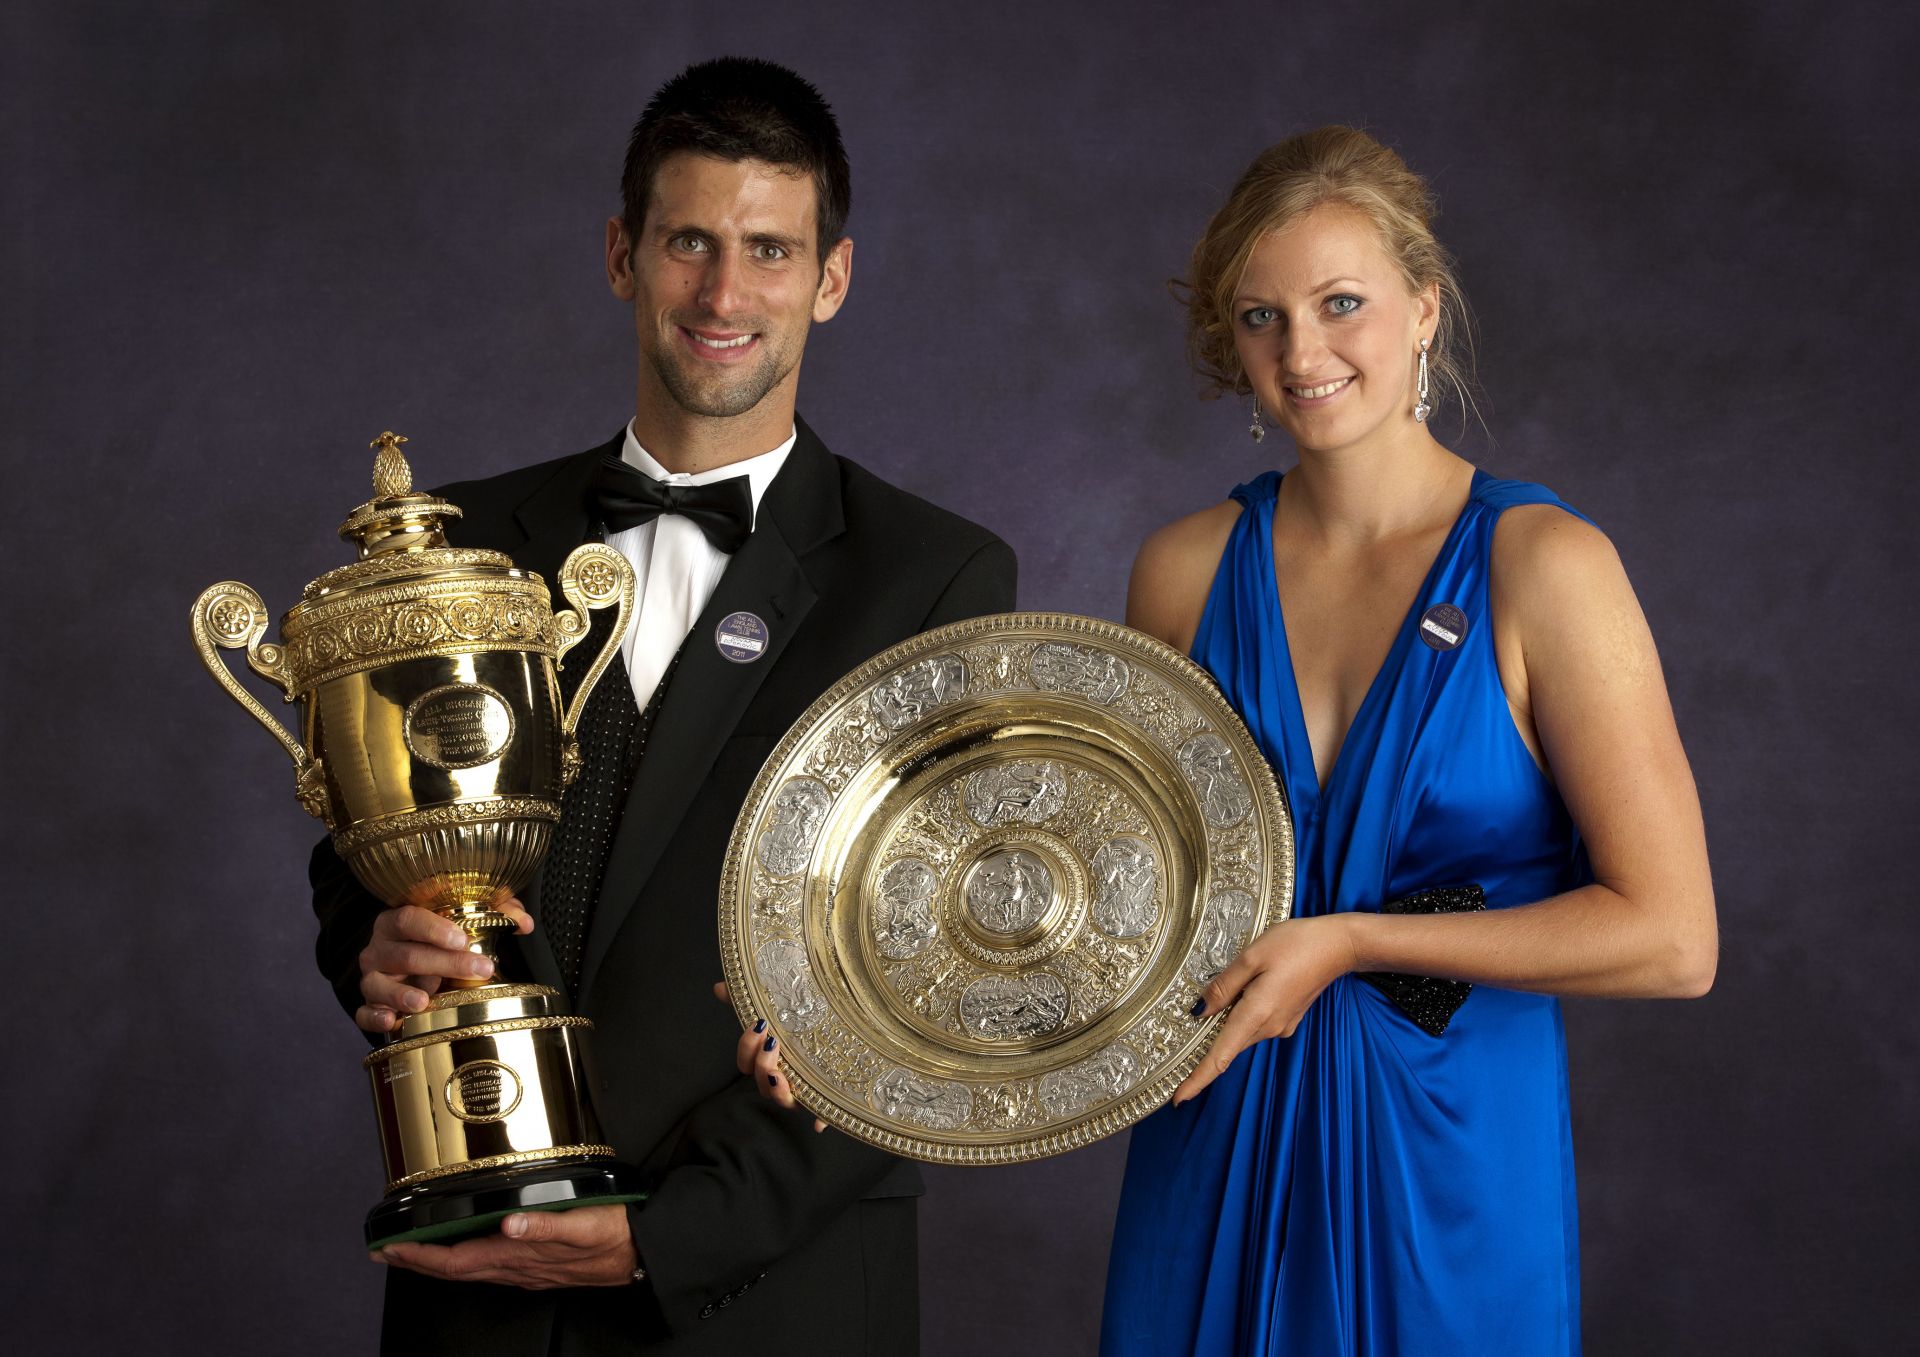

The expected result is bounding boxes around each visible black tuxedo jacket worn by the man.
[311,422,1014,1357]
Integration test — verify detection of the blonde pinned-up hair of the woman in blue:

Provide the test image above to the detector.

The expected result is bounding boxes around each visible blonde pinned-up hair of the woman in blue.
[1175,127,1473,428]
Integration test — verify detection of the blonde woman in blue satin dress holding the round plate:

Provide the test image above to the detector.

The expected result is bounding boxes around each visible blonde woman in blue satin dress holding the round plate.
[1102,127,1716,1357]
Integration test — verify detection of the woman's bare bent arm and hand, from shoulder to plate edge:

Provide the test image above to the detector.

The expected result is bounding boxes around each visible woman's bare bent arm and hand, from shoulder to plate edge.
[1175,507,1718,1102]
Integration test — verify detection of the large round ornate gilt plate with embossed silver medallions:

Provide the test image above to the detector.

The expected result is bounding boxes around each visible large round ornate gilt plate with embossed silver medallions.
[720,612,1294,1163]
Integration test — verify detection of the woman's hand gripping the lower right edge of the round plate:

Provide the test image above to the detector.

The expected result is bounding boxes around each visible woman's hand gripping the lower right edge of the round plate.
[1173,914,1357,1106]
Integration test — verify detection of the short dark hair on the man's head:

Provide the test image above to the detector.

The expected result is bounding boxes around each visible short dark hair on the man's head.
[620,56,852,261]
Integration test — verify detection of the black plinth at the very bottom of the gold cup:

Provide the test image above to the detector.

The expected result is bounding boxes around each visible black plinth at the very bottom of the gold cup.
[367,1157,647,1250]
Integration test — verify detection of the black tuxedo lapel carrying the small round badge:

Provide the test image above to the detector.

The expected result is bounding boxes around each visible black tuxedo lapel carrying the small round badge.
[580,422,845,1002]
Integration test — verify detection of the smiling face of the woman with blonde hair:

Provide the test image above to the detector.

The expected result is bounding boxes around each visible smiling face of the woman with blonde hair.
[1233,203,1440,451]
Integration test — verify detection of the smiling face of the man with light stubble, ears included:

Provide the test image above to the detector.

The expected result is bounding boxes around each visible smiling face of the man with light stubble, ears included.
[607,154,852,418]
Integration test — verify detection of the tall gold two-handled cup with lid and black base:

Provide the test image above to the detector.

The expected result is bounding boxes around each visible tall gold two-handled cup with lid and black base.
[192,434,637,1246]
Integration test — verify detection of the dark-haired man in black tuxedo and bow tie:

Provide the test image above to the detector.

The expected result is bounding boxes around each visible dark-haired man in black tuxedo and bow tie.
[311,60,1014,1357]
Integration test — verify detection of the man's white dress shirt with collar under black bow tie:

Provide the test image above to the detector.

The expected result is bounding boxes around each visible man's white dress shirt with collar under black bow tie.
[607,422,799,708]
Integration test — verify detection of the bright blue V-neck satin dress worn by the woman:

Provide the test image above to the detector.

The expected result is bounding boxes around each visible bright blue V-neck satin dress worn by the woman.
[1100,472,1588,1357]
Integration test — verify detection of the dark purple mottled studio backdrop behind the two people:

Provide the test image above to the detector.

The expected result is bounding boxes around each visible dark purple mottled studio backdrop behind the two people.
[0,0,1920,1357]
